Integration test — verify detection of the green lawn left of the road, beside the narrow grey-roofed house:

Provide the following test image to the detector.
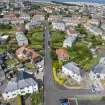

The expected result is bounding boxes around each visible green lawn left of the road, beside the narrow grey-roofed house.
[27,27,44,54]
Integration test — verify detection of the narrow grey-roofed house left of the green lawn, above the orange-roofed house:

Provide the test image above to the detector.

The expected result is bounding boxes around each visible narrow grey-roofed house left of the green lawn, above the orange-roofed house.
[16,32,28,46]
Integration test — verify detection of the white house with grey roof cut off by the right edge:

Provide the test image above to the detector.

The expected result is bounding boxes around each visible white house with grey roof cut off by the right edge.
[89,61,105,80]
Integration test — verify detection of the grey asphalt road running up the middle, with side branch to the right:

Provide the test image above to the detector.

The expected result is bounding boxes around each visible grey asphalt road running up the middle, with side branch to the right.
[44,21,105,105]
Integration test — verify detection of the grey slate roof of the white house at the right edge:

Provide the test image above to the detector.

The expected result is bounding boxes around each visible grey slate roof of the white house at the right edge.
[93,64,105,74]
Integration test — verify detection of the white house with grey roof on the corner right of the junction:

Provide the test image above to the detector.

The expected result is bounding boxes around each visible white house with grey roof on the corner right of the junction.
[62,62,82,82]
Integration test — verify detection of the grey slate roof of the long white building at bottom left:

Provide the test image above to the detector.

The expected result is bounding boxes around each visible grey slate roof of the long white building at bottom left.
[4,68,37,92]
